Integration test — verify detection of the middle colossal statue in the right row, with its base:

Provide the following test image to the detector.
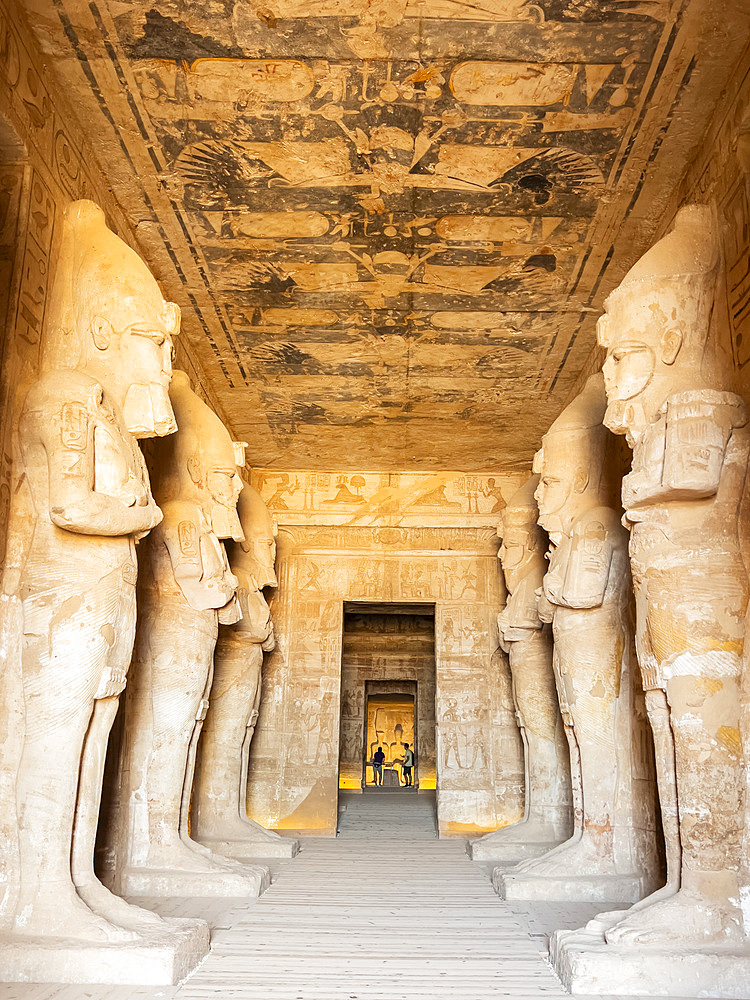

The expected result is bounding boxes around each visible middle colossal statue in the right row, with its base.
[494,374,658,902]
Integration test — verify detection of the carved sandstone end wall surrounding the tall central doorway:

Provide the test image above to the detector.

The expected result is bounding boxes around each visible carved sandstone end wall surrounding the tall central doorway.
[248,470,523,835]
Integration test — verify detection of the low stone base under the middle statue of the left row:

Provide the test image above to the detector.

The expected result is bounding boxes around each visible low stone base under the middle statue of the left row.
[117,865,271,898]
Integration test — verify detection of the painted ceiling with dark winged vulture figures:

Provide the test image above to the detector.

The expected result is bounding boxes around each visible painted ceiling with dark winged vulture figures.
[22,0,739,471]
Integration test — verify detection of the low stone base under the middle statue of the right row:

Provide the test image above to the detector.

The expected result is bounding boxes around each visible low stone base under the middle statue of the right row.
[492,868,644,908]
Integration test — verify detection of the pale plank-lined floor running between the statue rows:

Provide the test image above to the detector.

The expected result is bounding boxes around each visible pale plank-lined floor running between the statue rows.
[0,793,704,1000]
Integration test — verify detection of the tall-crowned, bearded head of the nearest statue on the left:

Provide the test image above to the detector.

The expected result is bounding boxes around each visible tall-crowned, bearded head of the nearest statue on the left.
[45,201,180,438]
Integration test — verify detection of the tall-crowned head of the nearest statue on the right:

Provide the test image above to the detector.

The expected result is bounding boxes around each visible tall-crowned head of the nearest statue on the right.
[597,205,721,447]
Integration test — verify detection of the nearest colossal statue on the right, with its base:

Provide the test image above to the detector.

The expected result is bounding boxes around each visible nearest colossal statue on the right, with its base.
[555,205,750,997]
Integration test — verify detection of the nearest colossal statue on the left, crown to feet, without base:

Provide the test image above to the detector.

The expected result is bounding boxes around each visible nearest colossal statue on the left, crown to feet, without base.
[0,201,180,944]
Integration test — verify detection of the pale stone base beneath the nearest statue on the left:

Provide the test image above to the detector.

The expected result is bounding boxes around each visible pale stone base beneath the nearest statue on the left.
[0,917,210,986]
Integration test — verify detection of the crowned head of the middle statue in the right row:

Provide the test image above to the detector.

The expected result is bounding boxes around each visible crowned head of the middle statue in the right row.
[534,372,609,544]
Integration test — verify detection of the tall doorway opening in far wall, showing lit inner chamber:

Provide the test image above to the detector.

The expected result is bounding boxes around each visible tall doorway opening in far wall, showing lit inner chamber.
[339,601,436,794]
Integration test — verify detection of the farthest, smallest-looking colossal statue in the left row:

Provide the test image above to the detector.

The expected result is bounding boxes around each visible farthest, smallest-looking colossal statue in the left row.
[192,480,299,858]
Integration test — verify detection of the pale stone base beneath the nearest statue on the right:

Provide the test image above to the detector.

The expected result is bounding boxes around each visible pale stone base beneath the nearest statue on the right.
[550,930,750,1000]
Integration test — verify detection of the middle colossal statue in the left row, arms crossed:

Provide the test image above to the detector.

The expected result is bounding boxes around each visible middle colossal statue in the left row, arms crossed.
[106,371,268,896]
